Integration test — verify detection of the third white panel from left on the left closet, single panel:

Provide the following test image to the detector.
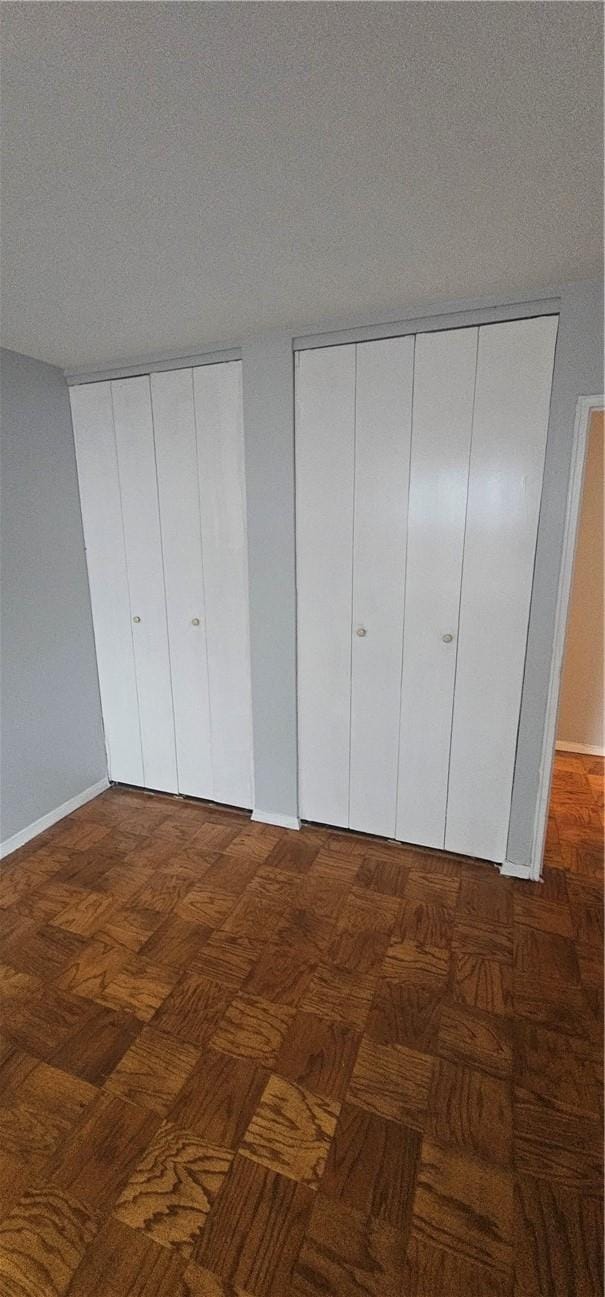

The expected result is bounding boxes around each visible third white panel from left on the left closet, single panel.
[151,370,214,798]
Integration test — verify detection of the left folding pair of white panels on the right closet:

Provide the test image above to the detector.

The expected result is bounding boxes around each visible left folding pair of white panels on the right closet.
[296,339,414,834]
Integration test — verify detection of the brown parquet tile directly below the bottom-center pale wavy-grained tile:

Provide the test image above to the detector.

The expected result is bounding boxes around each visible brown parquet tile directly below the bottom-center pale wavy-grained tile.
[193,1157,317,1297]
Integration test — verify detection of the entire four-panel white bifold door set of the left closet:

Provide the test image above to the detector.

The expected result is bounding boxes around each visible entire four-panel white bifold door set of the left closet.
[71,362,252,805]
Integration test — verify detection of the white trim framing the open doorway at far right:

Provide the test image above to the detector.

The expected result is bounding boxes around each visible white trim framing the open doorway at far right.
[521,394,605,881]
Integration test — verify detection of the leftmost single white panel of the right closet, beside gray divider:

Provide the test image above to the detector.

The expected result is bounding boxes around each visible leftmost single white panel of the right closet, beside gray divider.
[296,346,356,826]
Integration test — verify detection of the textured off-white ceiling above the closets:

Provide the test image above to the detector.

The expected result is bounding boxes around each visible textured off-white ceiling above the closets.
[0,3,602,368]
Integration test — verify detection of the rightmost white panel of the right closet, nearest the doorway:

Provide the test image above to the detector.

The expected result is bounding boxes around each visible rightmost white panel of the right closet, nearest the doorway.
[445,318,557,861]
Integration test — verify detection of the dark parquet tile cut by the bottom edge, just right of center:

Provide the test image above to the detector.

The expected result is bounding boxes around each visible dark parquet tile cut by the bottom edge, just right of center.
[292,1195,405,1297]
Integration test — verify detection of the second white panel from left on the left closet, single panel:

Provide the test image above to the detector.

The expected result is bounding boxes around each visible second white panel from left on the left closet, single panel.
[112,377,178,792]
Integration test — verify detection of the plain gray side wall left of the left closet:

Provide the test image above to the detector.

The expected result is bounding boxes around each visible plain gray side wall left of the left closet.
[0,350,106,842]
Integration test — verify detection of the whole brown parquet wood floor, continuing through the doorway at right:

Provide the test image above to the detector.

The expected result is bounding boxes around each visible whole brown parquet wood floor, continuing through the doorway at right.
[0,755,604,1297]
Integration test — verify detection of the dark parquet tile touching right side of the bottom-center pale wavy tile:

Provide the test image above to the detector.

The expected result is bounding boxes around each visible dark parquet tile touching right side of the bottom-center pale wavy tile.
[321,1104,421,1237]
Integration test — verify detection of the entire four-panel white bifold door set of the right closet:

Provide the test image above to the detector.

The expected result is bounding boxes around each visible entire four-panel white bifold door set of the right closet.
[296,318,557,861]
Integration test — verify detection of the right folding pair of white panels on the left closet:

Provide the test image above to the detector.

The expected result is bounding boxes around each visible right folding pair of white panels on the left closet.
[151,361,252,807]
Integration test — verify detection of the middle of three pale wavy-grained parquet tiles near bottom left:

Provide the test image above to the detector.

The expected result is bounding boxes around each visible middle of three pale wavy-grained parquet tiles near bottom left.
[114,1122,234,1258]
